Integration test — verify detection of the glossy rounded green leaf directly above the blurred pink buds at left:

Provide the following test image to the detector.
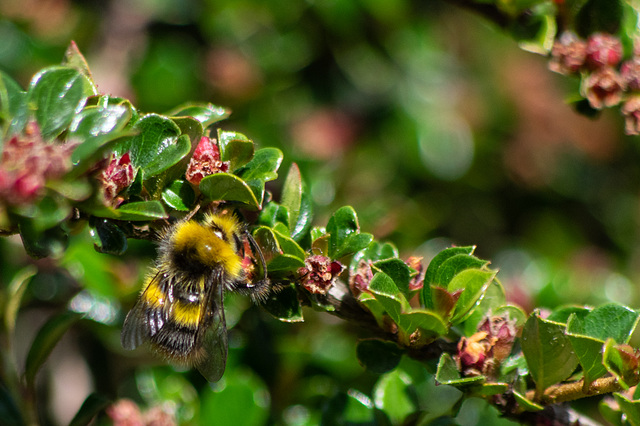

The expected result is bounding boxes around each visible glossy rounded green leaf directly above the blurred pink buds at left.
[27,66,95,139]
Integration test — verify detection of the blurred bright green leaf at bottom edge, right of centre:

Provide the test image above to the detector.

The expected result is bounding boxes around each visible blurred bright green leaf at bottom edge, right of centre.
[373,369,418,424]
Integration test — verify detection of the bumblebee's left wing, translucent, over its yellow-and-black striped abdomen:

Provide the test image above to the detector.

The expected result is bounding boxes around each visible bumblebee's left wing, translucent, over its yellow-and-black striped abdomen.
[120,271,173,350]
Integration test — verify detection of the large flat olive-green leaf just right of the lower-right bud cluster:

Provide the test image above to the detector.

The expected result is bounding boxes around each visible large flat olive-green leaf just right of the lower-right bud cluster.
[521,311,578,395]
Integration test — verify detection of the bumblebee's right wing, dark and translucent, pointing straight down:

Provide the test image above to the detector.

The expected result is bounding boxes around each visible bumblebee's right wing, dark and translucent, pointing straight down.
[195,274,228,382]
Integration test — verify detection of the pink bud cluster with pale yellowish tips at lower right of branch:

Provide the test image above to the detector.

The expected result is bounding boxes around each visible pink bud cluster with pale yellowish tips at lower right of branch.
[456,316,517,377]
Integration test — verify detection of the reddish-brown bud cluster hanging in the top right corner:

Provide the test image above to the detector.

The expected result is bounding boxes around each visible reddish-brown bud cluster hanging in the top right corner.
[549,32,640,135]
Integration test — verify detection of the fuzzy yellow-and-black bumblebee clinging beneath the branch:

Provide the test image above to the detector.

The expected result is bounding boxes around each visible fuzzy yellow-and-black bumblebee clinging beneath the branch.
[121,214,269,382]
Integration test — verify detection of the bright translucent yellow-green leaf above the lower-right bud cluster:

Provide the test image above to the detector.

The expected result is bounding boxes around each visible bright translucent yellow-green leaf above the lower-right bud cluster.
[448,269,497,324]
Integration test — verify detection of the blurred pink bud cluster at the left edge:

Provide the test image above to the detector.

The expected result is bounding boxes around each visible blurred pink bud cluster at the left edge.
[0,123,75,206]
